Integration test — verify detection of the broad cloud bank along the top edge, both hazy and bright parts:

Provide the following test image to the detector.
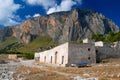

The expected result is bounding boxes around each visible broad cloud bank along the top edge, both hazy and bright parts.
[24,0,82,14]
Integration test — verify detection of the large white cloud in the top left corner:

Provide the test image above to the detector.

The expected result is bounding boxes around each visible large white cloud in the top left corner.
[0,0,20,26]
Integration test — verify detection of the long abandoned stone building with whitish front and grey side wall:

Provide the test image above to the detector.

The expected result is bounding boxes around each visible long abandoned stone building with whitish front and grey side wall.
[35,42,96,66]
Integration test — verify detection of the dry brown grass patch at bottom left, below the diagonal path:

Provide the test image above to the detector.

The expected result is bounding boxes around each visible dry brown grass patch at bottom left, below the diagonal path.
[14,66,70,80]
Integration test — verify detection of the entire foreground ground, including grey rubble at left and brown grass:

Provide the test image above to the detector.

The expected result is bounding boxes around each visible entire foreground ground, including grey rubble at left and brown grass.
[0,59,120,80]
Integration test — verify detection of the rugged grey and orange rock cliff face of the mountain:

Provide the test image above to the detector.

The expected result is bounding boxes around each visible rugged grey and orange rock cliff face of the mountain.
[2,9,119,43]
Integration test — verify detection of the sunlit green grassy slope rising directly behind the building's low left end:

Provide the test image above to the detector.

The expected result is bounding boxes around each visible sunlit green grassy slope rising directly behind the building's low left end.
[18,36,57,52]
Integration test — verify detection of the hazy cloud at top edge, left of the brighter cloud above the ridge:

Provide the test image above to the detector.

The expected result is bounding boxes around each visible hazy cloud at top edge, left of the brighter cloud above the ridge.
[24,0,56,10]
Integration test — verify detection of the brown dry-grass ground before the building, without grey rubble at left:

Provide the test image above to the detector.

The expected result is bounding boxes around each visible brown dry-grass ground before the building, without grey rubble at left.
[14,59,120,80]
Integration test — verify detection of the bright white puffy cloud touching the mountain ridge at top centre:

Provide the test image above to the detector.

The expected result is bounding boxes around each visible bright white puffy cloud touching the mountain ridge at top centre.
[47,0,82,14]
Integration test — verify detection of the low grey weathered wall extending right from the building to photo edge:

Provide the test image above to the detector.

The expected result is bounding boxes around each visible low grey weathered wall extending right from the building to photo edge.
[96,45,120,62]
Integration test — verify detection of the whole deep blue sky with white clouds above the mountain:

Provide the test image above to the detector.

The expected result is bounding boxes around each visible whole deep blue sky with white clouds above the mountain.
[0,0,120,27]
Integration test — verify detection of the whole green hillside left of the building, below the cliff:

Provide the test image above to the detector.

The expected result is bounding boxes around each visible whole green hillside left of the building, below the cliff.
[0,36,57,59]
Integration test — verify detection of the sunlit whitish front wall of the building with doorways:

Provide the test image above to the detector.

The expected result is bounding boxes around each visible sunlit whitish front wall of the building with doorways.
[39,43,68,66]
